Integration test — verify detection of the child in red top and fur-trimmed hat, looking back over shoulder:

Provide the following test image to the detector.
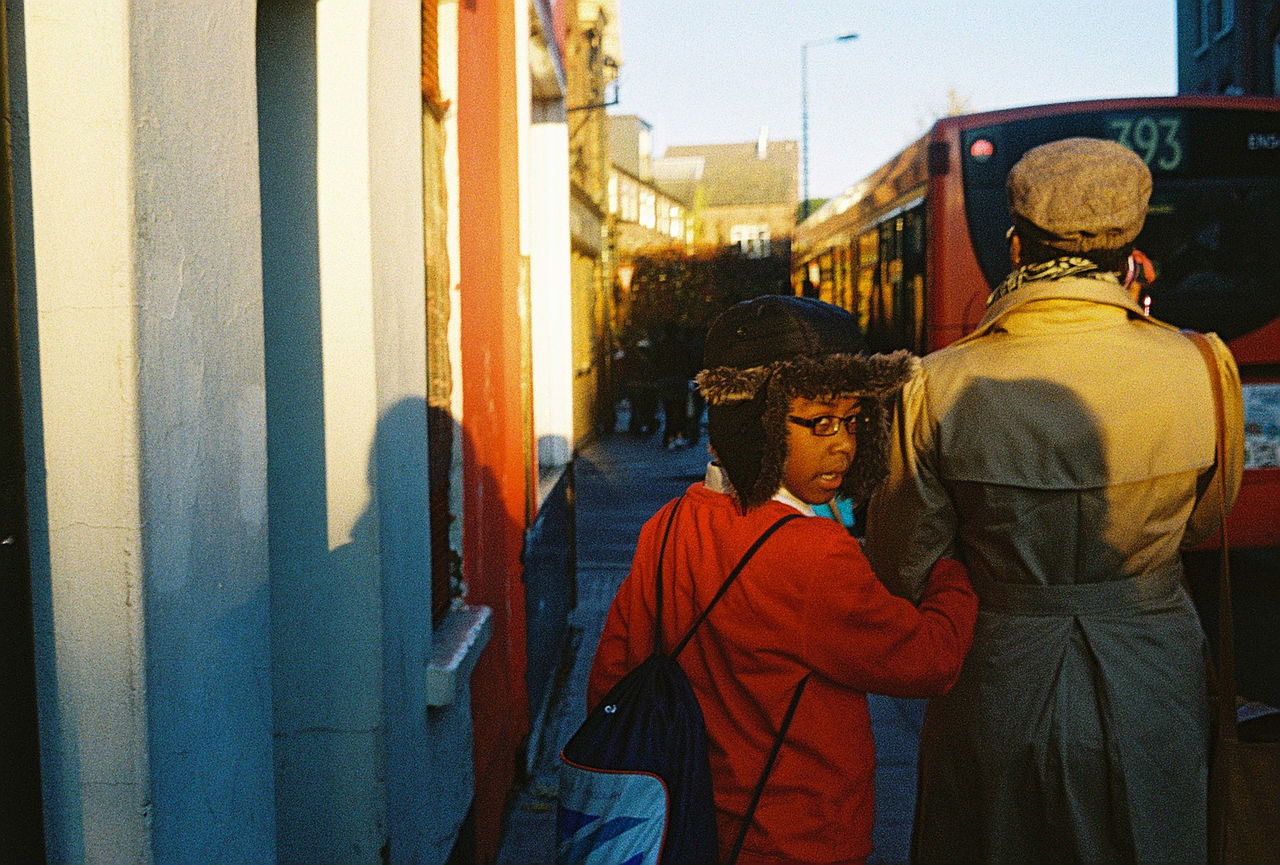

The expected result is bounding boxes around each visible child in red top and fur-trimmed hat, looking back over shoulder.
[588,296,977,865]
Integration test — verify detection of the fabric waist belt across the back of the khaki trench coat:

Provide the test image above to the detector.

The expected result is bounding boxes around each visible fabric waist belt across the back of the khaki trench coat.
[972,564,1181,615]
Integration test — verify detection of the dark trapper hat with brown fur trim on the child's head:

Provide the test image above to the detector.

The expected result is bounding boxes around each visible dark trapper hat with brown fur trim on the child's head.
[696,294,919,508]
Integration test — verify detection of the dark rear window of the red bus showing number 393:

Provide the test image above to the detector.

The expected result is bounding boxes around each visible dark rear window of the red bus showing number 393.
[961,107,1280,340]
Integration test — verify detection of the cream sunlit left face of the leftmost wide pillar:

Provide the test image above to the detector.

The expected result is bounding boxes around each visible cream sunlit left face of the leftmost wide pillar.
[24,6,150,862]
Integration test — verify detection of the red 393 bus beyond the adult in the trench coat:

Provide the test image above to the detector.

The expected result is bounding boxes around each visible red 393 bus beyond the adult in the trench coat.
[791,96,1280,548]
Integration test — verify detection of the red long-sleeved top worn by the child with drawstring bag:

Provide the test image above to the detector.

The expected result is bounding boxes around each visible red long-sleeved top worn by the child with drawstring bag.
[588,484,978,865]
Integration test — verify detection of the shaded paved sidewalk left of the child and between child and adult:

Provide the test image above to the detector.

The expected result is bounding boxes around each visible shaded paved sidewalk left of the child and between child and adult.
[497,433,924,865]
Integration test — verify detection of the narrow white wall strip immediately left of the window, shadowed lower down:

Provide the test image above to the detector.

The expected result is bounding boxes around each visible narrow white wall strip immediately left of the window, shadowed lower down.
[367,0,437,862]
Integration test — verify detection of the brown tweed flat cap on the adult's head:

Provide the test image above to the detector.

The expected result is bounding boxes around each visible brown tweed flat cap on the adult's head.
[1007,138,1151,253]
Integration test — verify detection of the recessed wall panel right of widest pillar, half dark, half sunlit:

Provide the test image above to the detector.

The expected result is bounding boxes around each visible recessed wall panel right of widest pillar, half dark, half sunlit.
[260,0,389,862]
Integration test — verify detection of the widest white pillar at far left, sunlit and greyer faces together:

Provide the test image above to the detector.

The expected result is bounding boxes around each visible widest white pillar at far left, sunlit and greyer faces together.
[19,0,275,862]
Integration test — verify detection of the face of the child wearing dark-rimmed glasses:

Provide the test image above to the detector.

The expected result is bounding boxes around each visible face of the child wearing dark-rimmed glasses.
[782,397,859,504]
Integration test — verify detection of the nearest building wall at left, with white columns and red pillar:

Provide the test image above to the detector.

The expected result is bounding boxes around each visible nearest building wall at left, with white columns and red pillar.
[0,0,603,862]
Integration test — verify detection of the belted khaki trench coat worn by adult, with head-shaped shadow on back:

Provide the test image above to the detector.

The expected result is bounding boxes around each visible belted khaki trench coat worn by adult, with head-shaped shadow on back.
[867,276,1243,862]
